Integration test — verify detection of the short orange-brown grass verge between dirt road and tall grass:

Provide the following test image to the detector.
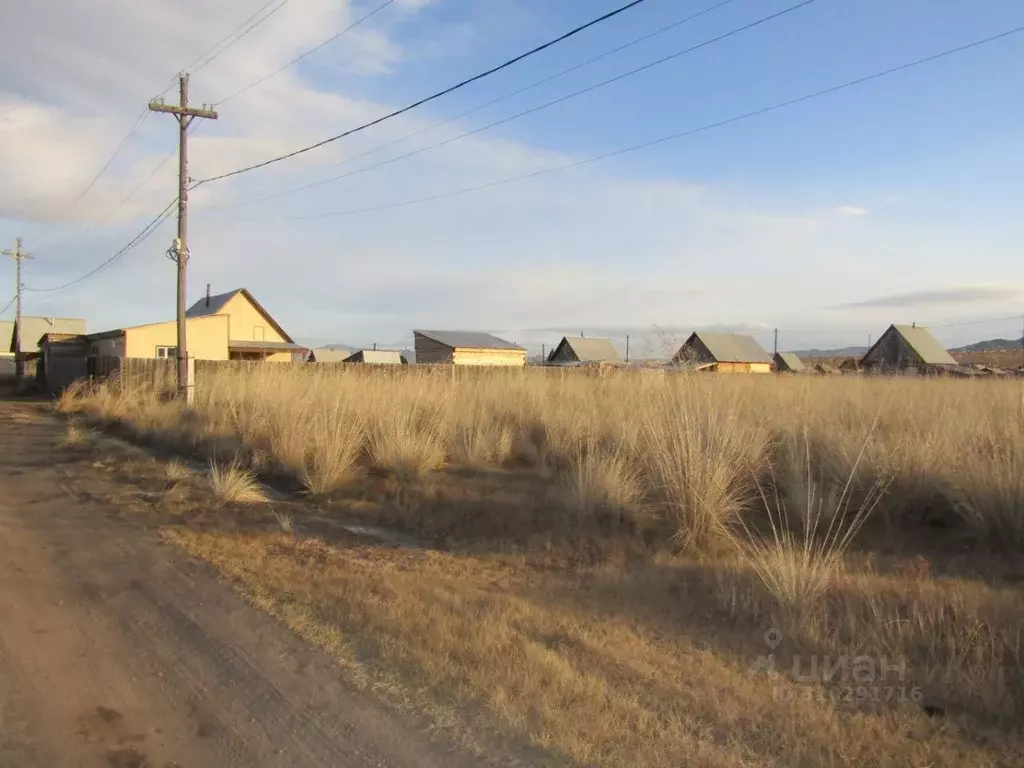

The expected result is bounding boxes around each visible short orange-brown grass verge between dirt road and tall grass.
[167,528,1024,768]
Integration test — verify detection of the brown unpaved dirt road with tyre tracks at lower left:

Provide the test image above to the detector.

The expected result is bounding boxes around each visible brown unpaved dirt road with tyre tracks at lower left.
[0,401,499,768]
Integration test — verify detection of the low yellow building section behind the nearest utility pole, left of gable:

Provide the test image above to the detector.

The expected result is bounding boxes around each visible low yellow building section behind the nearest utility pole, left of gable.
[84,314,229,360]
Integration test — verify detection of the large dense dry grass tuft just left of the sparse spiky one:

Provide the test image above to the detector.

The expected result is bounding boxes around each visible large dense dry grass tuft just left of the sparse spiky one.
[642,381,767,552]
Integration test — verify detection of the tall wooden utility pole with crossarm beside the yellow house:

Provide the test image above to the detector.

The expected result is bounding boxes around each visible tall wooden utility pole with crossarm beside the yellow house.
[150,72,217,403]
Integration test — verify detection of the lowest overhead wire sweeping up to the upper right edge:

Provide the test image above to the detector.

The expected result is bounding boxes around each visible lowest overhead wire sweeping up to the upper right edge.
[247,26,1024,222]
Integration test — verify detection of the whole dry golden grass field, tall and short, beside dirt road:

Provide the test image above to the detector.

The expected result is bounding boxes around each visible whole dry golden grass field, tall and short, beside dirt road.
[58,366,1024,767]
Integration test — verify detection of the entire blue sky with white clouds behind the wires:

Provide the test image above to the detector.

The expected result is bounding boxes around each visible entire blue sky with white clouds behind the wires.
[0,0,1024,351]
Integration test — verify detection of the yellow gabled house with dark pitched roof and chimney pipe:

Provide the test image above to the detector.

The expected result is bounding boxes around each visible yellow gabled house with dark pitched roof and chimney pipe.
[185,288,307,362]
